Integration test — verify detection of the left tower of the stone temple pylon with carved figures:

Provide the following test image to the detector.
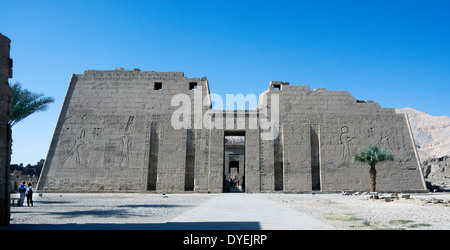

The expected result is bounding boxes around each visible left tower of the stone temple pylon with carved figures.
[38,70,209,192]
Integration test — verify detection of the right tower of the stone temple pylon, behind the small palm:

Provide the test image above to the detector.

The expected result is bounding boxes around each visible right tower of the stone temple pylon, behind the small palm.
[270,85,424,192]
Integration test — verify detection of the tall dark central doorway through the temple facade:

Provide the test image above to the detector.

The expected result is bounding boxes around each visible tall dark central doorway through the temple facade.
[223,131,245,193]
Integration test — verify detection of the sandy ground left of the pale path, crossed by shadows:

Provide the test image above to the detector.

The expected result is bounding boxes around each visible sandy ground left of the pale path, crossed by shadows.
[10,193,213,224]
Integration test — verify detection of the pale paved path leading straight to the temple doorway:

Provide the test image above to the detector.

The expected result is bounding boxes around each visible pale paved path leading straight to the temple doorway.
[171,193,335,230]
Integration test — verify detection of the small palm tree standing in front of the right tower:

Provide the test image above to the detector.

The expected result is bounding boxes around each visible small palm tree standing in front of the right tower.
[352,146,394,192]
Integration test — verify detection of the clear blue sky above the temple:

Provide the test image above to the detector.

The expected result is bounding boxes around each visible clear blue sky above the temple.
[0,0,450,165]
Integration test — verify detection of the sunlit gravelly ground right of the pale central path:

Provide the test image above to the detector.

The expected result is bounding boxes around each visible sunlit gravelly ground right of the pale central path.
[267,193,450,230]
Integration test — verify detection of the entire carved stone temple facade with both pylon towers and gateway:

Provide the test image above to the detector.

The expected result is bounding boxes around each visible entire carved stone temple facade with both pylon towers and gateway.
[38,68,425,193]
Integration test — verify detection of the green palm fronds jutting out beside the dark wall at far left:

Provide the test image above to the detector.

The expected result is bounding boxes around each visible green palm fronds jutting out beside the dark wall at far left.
[8,82,55,127]
